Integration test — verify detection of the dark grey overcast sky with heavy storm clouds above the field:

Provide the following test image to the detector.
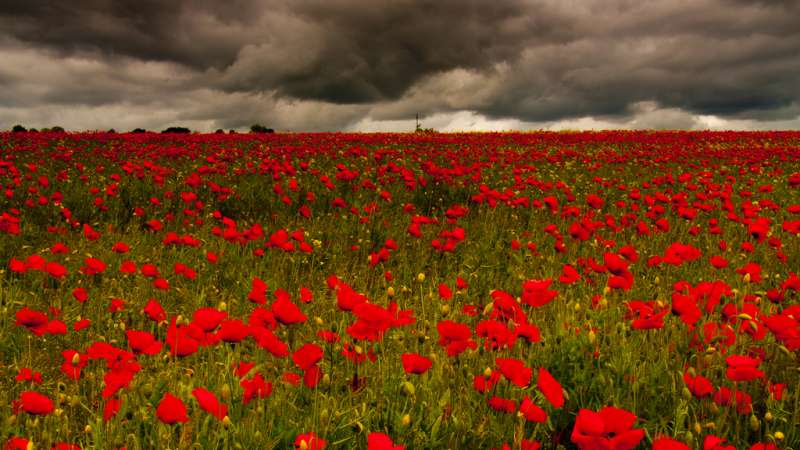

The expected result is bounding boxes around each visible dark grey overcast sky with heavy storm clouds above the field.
[0,0,800,131]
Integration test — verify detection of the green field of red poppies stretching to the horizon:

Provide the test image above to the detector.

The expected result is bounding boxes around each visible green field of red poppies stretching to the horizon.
[0,131,800,450]
